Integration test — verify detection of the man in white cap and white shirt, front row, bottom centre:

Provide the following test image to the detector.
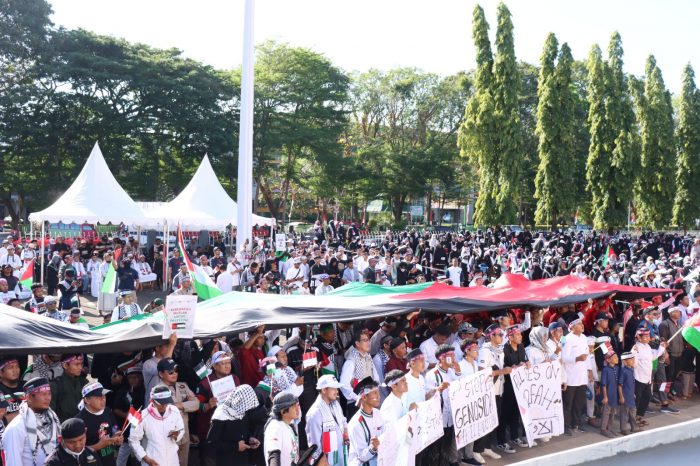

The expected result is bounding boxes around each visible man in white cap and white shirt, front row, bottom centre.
[306,374,348,466]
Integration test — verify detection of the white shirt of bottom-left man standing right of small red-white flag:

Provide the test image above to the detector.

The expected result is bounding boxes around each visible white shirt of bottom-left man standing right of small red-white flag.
[129,405,185,466]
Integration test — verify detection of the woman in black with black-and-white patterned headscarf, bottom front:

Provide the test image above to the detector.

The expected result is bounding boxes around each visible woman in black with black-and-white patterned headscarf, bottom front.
[207,385,265,466]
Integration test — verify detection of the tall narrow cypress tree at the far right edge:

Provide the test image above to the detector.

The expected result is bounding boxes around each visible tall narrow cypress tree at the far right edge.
[673,63,700,229]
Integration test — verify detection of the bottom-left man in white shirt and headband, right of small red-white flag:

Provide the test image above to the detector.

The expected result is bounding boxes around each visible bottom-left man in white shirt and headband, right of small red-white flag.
[129,385,185,466]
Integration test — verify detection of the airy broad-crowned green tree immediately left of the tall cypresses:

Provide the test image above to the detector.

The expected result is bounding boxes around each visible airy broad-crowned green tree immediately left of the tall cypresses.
[347,68,470,223]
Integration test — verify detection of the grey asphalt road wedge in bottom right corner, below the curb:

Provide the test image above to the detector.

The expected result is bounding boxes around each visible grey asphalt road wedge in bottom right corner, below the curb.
[586,439,700,466]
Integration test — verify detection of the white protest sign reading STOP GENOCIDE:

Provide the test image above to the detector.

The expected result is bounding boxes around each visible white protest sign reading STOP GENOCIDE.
[450,369,498,449]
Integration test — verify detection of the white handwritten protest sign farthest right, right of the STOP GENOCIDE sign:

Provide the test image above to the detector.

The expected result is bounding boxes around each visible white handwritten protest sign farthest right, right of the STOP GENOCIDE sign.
[510,361,564,446]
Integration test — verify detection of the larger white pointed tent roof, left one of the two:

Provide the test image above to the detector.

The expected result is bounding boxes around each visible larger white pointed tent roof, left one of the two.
[29,142,143,224]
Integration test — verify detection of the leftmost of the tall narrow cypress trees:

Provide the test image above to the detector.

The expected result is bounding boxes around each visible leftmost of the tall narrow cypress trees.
[458,5,500,225]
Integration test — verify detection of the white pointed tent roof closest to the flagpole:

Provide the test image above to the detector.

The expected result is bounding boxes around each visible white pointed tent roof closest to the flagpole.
[145,155,274,230]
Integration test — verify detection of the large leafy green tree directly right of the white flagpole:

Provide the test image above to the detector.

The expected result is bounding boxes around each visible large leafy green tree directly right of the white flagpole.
[253,42,349,221]
